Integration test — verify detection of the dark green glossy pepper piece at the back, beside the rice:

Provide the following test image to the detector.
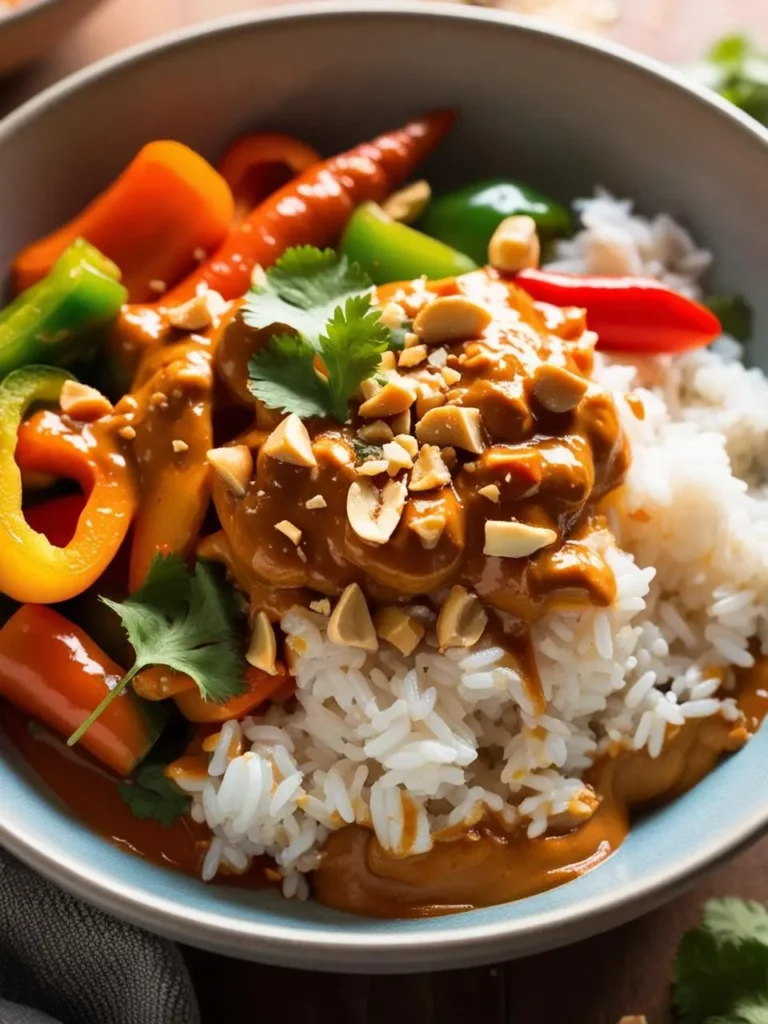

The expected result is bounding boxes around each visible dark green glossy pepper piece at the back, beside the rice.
[418,178,572,264]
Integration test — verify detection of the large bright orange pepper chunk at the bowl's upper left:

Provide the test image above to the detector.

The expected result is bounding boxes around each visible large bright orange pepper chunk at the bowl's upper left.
[12,141,234,302]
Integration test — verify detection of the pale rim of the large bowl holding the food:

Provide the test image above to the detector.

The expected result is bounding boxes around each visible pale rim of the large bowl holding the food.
[0,0,768,971]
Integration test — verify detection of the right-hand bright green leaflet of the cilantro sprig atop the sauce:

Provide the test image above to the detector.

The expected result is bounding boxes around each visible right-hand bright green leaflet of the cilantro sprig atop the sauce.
[319,295,389,423]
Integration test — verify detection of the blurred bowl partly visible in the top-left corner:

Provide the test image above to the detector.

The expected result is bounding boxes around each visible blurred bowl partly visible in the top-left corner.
[0,0,108,75]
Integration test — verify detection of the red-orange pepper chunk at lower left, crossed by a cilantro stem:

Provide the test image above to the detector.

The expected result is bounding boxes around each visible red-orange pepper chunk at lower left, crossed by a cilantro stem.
[0,604,167,775]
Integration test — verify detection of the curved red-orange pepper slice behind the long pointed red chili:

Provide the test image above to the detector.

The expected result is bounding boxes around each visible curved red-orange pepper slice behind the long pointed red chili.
[216,131,321,223]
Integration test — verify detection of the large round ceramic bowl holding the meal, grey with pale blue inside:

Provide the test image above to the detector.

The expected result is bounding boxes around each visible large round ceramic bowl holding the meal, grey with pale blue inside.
[0,0,768,972]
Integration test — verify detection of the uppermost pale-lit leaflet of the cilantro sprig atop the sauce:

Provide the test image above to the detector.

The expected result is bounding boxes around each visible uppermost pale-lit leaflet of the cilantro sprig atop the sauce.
[243,246,372,348]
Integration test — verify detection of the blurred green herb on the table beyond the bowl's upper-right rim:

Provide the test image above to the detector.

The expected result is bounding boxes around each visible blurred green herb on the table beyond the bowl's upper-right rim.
[691,35,768,125]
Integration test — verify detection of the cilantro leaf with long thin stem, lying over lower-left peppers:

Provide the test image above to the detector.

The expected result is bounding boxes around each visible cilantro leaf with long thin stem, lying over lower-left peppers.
[67,555,245,746]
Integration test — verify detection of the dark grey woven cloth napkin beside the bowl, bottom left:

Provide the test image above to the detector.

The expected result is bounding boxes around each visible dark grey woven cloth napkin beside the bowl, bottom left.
[0,850,200,1024]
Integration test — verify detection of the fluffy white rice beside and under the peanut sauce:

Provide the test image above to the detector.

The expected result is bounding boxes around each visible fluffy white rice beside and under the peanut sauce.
[184,191,768,898]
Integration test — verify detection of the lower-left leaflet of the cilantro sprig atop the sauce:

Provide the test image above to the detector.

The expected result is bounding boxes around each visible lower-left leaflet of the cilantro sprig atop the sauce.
[248,334,329,419]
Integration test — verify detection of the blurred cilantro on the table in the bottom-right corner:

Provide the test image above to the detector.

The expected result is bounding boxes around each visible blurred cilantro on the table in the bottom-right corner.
[673,899,768,1024]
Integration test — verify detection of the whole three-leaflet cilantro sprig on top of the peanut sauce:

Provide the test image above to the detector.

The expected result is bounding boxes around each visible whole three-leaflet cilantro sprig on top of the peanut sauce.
[243,246,390,423]
